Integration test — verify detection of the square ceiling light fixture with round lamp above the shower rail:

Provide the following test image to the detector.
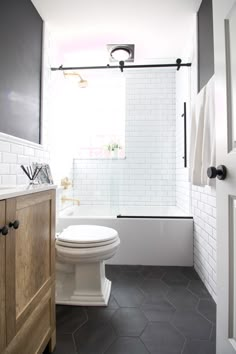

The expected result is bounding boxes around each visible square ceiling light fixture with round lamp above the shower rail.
[107,44,134,62]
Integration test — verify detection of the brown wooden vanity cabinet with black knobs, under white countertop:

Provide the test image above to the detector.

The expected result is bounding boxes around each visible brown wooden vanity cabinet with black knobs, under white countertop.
[0,189,56,354]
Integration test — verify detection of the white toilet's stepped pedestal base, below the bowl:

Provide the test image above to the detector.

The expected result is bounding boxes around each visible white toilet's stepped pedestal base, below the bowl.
[56,262,111,306]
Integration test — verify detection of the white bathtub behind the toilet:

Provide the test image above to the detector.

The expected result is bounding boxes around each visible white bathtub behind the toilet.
[57,206,193,266]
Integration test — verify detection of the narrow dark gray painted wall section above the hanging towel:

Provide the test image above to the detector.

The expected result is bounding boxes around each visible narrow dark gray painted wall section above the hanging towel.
[198,0,214,91]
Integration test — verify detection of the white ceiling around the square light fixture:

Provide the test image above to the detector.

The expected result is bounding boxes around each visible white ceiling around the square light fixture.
[32,0,201,65]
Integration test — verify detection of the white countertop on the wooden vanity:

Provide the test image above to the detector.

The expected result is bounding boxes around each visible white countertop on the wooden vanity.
[0,184,57,200]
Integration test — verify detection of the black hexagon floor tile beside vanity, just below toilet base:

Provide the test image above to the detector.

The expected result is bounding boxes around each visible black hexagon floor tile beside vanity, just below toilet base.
[56,305,87,334]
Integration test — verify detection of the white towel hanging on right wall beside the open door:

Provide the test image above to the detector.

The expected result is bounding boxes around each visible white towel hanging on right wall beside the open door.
[189,78,215,186]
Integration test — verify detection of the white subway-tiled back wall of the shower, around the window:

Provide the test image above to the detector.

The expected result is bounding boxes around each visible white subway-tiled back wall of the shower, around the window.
[73,69,176,206]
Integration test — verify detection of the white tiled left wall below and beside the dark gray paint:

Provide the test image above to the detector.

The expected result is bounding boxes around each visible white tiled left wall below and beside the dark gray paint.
[0,25,51,185]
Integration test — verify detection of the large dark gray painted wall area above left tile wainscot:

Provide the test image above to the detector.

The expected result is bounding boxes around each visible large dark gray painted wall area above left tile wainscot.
[0,0,43,143]
